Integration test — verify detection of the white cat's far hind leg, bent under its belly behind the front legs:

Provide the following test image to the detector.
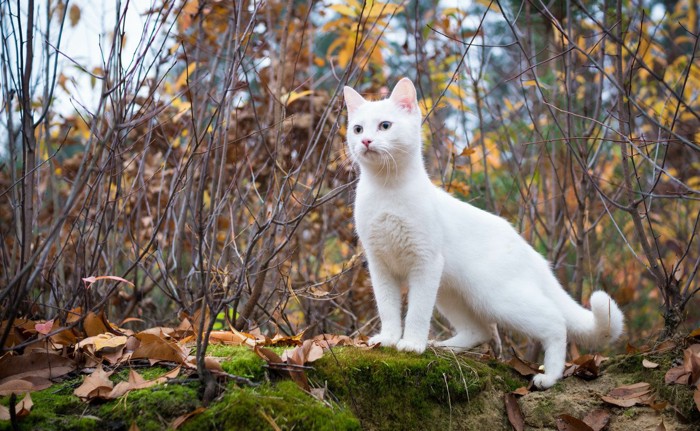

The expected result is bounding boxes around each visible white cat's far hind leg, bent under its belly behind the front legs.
[432,290,492,351]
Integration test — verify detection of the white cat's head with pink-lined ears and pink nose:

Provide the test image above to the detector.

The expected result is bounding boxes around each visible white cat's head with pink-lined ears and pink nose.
[344,78,421,169]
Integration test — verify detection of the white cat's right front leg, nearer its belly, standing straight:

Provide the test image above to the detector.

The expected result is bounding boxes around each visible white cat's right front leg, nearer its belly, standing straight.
[396,255,445,353]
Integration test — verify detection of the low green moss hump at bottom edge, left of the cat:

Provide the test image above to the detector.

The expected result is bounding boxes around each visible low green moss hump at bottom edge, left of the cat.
[181,381,360,431]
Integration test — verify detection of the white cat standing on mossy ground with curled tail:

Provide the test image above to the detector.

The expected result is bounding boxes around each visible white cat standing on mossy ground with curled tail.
[345,78,624,388]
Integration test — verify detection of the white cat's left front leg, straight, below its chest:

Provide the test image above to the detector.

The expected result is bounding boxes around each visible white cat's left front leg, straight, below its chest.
[367,256,401,346]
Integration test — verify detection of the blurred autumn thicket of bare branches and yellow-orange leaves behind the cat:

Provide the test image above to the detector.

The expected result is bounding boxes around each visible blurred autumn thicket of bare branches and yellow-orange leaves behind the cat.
[0,0,700,356]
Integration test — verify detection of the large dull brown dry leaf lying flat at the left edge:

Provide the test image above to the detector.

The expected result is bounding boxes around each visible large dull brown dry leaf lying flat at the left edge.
[0,351,76,383]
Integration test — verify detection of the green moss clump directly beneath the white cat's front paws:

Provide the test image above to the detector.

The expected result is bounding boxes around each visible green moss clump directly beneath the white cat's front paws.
[309,348,506,430]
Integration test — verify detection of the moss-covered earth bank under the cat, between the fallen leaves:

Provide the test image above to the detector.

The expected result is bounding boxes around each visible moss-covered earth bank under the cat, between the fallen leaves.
[0,346,700,431]
